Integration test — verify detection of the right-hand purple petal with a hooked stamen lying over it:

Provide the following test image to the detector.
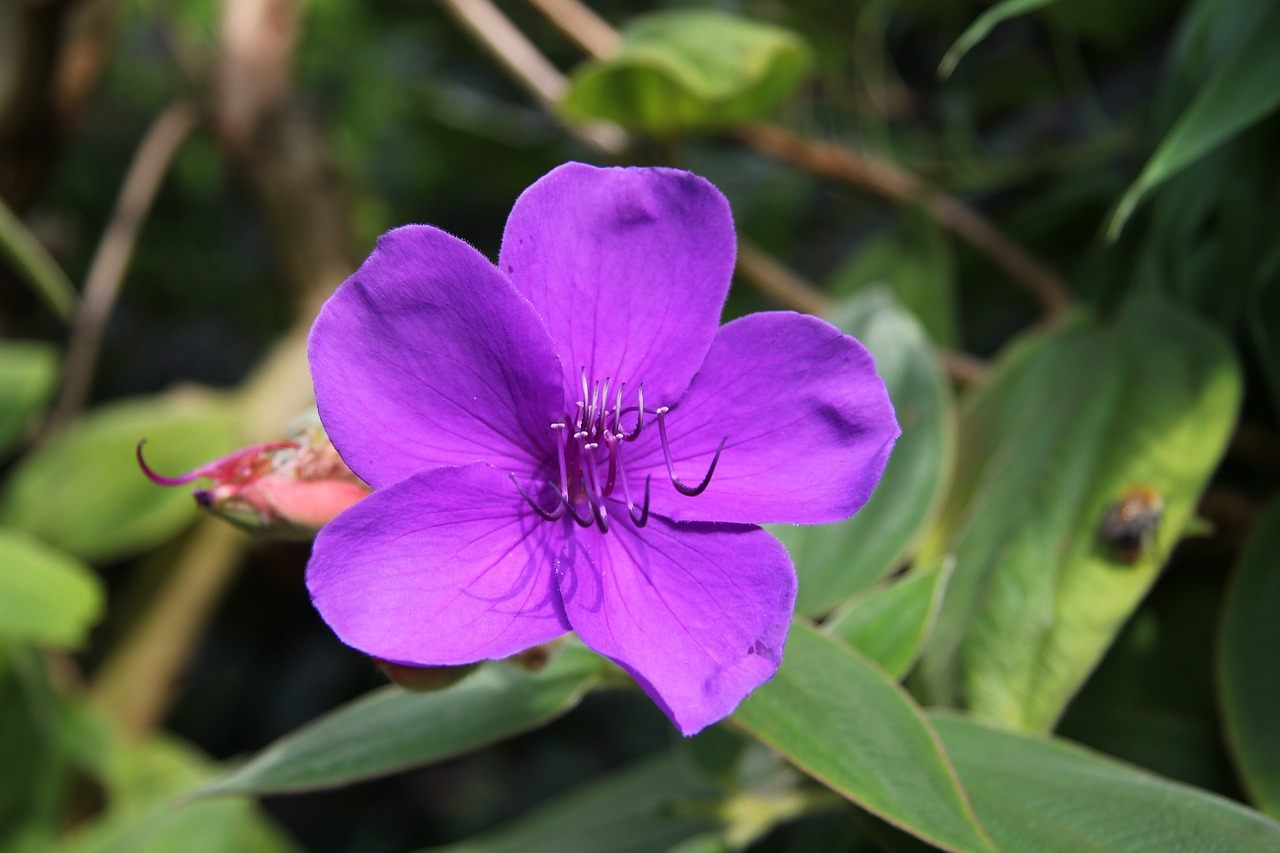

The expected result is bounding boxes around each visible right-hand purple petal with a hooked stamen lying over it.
[626,311,900,524]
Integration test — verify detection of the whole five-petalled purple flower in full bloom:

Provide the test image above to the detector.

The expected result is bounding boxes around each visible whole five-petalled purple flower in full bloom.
[307,163,899,735]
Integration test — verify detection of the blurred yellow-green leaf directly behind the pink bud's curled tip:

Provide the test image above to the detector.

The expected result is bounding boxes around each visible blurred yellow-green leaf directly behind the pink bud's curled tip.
[0,393,237,561]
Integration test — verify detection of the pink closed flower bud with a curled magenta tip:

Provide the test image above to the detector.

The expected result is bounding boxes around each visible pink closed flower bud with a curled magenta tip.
[137,427,372,538]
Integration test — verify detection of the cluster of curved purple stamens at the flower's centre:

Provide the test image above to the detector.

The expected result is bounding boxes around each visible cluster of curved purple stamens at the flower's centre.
[511,368,728,533]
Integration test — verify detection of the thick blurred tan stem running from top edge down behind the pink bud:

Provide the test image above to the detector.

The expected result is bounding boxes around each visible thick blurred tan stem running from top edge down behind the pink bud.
[91,0,353,735]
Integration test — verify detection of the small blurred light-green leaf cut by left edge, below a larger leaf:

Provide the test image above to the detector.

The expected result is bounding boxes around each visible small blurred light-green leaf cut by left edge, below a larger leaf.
[0,529,102,648]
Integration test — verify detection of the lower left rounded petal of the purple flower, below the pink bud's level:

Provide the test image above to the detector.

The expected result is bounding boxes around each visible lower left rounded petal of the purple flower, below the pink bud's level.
[307,465,570,666]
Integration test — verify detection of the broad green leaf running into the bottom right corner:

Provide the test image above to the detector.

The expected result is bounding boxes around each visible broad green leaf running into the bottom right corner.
[933,715,1280,853]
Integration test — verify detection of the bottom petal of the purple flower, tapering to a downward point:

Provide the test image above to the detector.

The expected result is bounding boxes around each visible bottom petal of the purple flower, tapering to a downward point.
[559,519,796,735]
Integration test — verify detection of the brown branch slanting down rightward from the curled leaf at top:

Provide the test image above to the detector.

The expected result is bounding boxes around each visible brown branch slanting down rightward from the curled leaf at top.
[733,124,1071,319]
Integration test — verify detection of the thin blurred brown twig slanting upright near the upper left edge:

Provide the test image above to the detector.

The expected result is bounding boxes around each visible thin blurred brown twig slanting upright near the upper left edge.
[49,101,196,432]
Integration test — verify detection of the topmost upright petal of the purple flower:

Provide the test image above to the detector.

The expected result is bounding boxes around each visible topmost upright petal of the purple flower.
[498,163,736,406]
